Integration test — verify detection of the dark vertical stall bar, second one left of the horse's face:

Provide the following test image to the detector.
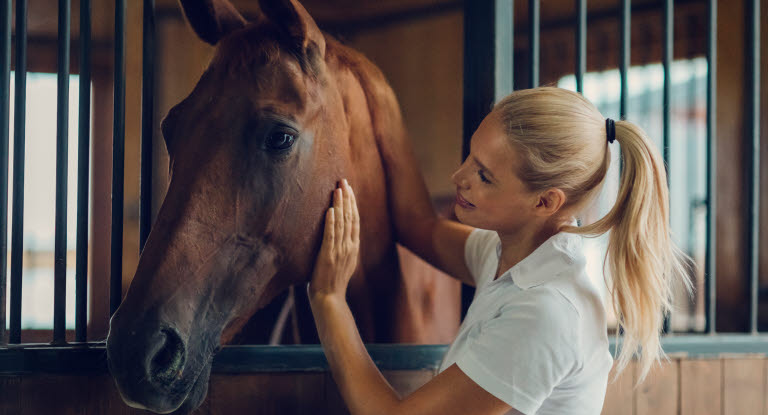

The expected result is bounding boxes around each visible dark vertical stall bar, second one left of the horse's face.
[109,0,125,316]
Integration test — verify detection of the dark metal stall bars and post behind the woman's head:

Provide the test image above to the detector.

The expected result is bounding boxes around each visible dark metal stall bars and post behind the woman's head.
[462,0,760,342]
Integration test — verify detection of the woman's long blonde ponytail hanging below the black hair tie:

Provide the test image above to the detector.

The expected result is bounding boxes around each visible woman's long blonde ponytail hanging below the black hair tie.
[564,121,693,387]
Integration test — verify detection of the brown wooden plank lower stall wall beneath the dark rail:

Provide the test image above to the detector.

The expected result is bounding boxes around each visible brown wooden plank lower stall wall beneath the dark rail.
[0,355,768,415]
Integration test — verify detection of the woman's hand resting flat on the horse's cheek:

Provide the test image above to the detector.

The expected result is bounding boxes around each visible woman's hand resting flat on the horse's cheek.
[307,179,360,300]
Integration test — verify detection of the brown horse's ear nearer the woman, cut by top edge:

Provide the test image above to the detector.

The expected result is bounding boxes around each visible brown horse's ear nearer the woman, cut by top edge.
[259,0,325,59]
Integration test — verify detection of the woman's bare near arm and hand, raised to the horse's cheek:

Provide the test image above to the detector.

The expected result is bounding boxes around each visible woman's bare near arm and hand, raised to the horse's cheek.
[307,181,511,415]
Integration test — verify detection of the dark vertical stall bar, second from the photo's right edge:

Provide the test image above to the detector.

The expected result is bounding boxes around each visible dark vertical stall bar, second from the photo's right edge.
[704,0,718,334]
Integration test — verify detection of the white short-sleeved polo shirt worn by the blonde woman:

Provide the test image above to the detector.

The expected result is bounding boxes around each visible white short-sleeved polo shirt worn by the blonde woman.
[439,229,613,415]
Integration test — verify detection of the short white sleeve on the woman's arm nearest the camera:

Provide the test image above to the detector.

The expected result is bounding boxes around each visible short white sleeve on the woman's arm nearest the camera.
[456,294,578,415]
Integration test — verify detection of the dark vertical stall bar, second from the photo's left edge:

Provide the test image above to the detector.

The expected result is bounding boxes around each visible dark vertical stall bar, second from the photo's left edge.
[8,0,27,344]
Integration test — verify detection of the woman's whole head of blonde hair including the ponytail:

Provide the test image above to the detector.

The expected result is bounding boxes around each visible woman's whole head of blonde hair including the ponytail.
[494,87,693,387]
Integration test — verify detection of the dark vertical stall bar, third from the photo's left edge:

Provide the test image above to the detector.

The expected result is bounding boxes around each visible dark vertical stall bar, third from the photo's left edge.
[53,0,70,344]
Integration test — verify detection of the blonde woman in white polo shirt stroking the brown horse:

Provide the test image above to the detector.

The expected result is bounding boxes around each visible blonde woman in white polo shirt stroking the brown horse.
[307,87,692,414]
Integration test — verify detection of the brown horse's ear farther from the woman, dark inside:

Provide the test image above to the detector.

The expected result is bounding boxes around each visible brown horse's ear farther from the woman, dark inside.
[179,0,246,45]
